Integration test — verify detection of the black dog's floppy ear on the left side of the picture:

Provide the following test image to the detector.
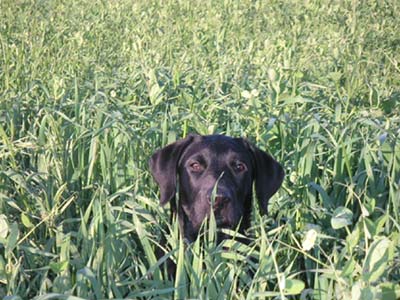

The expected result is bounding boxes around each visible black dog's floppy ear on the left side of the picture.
[149,134,196,205]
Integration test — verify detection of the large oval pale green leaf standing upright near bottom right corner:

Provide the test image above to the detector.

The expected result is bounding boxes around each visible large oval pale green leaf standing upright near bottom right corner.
[362,237,390,282]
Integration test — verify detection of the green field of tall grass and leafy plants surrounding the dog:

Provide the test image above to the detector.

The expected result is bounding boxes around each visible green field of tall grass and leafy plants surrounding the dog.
[0,0,400,300]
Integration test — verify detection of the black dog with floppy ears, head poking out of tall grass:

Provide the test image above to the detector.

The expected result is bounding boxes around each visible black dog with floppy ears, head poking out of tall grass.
[149,135,284,241]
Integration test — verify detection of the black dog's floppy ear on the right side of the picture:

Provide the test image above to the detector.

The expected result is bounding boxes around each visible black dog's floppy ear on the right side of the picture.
[248,143,285,214]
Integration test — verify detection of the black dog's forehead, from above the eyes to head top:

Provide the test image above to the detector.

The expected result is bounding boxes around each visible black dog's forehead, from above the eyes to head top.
[184,135,249,159]
